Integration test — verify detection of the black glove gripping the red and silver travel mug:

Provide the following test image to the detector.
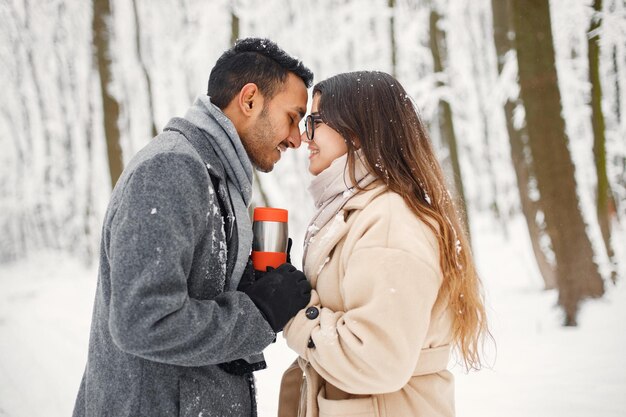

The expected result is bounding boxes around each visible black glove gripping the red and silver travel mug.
[243,263,311,333]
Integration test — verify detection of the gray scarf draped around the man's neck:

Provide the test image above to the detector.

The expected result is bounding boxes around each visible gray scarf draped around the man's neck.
[185,96,253,291]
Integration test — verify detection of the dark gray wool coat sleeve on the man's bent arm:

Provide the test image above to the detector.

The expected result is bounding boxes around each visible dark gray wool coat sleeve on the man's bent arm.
[108,152,275,366]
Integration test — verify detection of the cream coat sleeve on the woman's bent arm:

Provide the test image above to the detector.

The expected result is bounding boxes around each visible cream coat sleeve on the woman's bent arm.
[285,192,441,395]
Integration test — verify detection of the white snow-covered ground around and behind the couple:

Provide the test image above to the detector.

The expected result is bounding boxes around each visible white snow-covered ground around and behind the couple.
[0,214,626,417]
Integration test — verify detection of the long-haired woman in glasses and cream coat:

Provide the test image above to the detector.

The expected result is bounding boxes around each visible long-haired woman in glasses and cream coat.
[279,72,489,417]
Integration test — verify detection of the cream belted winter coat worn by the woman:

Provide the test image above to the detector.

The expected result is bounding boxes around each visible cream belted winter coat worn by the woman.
[278,184,454,417]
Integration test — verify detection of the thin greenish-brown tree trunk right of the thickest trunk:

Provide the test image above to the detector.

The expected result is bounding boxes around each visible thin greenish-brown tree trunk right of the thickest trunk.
[587,0,615,270]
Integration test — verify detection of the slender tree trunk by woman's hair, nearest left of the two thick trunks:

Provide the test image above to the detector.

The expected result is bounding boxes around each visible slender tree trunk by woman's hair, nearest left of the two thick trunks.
[430,9,470,236]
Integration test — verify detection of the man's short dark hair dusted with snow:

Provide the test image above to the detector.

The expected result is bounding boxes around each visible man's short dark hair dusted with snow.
[207,38,313,109]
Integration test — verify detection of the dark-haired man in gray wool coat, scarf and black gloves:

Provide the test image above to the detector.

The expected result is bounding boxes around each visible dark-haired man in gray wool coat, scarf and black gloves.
[74,39,313,417]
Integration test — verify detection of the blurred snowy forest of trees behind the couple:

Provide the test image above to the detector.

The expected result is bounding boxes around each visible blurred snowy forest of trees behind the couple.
[0,0,626,326]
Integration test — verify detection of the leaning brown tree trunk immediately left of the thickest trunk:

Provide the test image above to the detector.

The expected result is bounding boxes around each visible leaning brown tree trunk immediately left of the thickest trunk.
[491,0,557,289]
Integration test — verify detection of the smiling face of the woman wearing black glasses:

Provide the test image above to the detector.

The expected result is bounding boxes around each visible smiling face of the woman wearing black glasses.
[301,93,348,175]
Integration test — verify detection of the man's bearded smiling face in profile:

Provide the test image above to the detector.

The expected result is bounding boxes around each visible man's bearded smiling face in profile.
[241,73,307,172]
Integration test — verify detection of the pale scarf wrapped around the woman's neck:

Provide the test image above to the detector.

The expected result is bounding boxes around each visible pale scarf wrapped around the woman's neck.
[302,151,376,267]
